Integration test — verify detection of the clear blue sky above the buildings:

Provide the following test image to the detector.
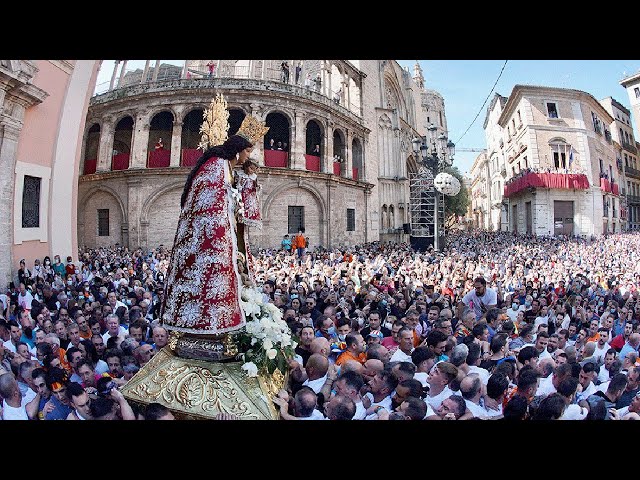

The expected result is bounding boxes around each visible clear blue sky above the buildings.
[96,60,640,173]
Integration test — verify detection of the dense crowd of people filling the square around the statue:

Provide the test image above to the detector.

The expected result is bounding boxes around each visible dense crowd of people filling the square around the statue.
[0,232,640,420]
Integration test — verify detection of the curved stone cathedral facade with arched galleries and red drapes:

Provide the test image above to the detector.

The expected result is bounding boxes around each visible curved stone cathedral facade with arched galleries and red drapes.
[77,60,447,248]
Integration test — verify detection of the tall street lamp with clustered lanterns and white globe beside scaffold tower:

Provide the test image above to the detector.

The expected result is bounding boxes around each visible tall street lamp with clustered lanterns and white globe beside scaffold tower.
[411,124,460,250]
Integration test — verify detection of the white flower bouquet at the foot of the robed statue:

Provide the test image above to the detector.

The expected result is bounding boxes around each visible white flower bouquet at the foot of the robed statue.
[235,287,296,377]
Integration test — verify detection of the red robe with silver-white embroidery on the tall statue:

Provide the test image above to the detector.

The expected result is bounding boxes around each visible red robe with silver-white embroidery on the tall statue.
[161,157,248,335]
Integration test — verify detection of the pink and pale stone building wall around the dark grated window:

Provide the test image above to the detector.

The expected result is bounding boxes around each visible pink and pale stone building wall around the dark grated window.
[0,60,99,282]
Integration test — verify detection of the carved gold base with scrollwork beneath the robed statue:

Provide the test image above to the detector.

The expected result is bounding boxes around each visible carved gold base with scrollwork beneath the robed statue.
[121,347,286,420]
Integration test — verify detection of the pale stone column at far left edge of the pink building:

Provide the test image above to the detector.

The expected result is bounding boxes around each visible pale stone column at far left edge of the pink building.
[0,124,20,286]
